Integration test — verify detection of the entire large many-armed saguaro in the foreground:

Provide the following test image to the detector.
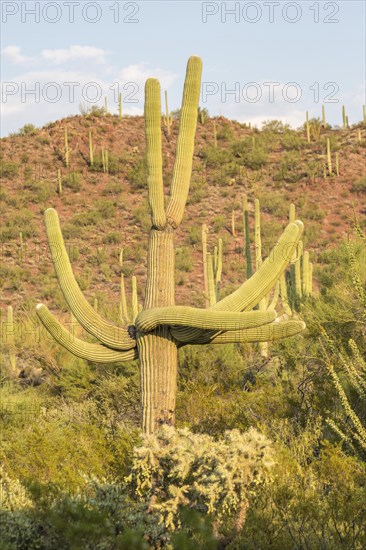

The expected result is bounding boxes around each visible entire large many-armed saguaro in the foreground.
[37,56,305,433]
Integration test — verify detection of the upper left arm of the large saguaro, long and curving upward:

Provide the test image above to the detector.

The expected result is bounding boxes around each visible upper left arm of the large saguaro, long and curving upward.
[45,208,136,350]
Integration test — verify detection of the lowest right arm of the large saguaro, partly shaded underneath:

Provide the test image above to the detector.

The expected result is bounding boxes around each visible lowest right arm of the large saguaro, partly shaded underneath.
[172,321,306,345]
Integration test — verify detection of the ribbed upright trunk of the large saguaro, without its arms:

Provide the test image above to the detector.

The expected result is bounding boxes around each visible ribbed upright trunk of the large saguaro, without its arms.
[137,228,178,433]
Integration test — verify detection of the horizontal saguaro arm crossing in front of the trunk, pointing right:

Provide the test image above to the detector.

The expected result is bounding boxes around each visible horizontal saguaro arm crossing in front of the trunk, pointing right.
[136,306,276,332]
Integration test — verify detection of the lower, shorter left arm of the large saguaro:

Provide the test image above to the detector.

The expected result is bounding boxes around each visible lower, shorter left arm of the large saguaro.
[36,304,138,363]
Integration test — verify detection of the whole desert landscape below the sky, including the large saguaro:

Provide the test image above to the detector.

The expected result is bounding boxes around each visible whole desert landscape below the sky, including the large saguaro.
[0,57,366,550]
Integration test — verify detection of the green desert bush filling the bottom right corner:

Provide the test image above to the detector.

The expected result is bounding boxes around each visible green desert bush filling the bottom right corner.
[237,423,366,550]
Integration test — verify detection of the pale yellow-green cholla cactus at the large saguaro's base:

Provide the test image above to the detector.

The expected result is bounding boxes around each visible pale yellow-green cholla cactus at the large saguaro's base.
[126,426,274,530]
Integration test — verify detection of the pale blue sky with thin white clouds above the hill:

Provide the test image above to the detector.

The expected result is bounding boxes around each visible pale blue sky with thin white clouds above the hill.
[0,0,366,136]
